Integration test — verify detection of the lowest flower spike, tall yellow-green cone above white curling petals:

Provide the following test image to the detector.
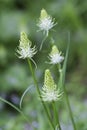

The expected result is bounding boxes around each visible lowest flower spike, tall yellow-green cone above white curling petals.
[41,69,62,102]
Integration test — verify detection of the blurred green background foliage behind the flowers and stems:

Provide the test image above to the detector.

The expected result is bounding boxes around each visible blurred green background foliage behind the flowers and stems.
[0,0,87,130]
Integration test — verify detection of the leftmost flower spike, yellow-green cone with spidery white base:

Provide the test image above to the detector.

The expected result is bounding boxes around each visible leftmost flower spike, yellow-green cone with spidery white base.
[17,32,37,59]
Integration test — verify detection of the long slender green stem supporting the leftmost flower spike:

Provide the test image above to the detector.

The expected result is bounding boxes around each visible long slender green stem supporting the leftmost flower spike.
[28,59,55,129]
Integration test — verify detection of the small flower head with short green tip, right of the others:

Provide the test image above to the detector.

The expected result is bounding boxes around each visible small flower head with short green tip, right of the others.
[49,45,64,64]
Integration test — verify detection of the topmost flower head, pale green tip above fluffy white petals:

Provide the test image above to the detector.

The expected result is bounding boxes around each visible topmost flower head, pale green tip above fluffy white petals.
[37,9,56,36]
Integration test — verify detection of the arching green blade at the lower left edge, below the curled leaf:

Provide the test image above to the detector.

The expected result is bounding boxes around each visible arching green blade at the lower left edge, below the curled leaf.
[0,97,29,122]
